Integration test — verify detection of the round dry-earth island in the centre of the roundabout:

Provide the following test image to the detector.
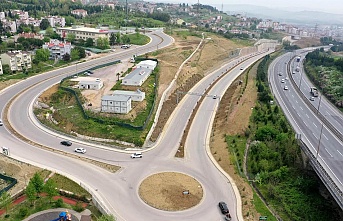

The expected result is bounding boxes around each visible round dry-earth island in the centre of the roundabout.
[139,172,203,211]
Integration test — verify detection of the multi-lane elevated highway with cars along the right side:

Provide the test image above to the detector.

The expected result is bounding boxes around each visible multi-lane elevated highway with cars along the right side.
[269,53,343,206]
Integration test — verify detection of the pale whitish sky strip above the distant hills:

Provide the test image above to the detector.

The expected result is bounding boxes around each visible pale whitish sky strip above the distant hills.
[152,0,343,14]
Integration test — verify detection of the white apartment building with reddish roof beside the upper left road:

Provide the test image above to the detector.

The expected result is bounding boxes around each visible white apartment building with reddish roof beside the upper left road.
[42,39,71,59]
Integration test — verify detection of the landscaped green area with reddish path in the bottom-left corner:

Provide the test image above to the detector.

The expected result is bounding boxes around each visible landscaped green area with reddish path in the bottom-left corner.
[0,170,109,221]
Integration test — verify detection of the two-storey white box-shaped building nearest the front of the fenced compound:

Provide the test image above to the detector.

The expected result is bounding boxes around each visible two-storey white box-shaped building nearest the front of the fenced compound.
[101,95,131,114]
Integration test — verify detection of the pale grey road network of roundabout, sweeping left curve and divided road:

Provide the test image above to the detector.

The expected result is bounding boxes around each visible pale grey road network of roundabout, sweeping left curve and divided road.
[0,28,272,221]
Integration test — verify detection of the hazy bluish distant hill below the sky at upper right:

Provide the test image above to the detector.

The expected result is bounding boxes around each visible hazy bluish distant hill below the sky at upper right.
[214,4,343,25]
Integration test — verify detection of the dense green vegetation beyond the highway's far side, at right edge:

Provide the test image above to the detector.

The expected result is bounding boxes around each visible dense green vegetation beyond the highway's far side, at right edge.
[304,48,343,111]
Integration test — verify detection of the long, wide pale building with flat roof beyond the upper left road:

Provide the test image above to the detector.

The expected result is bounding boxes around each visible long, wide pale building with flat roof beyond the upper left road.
[56,26,109,42]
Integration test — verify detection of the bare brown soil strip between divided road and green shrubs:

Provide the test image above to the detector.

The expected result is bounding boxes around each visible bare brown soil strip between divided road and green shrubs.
[210,65,259,220]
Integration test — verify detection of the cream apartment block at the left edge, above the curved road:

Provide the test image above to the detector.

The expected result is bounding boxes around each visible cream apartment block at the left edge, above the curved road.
[1,51,32,71]
